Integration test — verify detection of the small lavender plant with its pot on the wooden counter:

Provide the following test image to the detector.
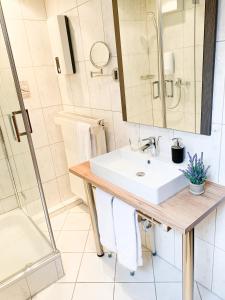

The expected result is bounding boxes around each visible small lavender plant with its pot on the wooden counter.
[180,152,209,195]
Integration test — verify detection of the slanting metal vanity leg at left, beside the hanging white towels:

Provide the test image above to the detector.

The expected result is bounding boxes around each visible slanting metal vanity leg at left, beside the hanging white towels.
[84,180,104,257]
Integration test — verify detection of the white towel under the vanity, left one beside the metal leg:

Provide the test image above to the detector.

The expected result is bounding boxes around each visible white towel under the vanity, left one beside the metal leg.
[95,188,116,252]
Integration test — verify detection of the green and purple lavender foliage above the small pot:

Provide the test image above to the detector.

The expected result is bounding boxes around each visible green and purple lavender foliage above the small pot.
[180,152,210,185]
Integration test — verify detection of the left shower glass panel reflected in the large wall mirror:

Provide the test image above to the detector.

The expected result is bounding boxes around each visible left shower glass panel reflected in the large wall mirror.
[118,0,156,125]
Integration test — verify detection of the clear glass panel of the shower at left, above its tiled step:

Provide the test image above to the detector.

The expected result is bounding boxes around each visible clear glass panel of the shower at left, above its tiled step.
[0,8,55,282]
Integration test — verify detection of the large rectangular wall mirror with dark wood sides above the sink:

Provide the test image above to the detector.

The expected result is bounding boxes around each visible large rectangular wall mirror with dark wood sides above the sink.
[112,0,217,135]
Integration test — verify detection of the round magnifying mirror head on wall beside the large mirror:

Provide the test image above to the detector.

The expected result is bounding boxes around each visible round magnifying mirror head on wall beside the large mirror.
[90,42,110,69]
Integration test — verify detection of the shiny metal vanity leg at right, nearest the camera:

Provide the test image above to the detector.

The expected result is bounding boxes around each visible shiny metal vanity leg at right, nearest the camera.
[182,229,194,300]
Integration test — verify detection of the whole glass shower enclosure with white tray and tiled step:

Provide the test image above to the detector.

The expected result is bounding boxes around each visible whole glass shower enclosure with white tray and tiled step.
[0,2,63,299]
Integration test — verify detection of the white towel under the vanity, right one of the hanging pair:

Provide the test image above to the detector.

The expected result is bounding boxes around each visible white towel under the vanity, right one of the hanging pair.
[113,198,143,271]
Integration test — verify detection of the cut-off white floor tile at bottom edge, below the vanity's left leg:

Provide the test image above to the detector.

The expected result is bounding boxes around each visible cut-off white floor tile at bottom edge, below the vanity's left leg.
[72,283,114,300]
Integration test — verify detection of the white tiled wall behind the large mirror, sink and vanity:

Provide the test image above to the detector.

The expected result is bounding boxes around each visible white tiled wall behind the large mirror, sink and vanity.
[46,0,225,299]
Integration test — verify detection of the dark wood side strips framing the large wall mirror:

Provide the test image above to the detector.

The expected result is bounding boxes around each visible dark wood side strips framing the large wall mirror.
[112,0,218,135]
